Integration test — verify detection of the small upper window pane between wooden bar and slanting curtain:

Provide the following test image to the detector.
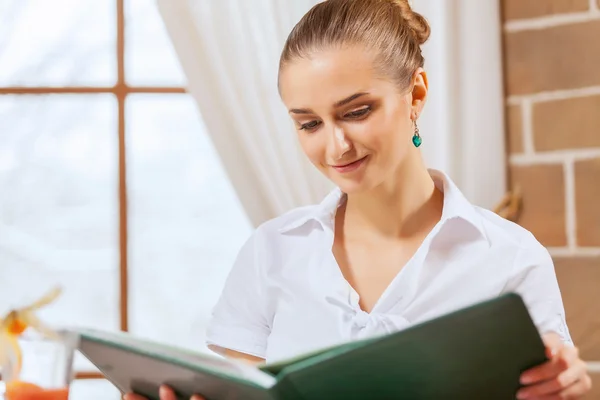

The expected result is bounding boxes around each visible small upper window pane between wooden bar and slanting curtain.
[125,0,186,86]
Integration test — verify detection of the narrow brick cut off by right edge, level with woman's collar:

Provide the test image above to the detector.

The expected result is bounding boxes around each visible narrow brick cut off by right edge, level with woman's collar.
[575,158,600,246]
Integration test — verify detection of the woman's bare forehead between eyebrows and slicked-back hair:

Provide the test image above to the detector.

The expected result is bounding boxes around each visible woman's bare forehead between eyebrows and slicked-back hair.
[279,47,392,108]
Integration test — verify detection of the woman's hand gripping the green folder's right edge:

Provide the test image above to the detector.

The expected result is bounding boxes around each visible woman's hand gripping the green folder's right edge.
[517,333,592,400]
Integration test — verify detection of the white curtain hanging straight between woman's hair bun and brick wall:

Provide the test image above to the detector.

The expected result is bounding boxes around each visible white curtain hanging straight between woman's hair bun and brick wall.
[411,0,506,208]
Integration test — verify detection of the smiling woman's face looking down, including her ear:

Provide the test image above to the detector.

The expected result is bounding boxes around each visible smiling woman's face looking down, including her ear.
[279,46,427,193]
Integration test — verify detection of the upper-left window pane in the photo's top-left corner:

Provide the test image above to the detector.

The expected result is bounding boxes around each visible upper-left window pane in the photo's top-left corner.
[0,0,116,86]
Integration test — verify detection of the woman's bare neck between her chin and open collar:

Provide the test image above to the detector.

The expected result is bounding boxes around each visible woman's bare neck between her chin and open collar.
[344,152,443,238]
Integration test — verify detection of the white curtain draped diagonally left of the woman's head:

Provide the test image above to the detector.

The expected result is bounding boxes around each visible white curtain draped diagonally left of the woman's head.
[158,0,331,225]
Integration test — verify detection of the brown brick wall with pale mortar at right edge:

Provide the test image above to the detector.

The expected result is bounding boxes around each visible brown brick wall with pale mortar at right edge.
[501,0,600,399]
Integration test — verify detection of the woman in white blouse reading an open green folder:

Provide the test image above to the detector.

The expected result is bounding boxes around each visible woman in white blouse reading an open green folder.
[126,0,591,400]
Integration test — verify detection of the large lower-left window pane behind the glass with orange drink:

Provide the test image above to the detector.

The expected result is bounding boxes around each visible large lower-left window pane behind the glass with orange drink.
[0,95,119,372]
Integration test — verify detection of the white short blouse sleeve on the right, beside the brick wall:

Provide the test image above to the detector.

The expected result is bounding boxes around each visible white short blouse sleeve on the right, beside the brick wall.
[506,234,573,344]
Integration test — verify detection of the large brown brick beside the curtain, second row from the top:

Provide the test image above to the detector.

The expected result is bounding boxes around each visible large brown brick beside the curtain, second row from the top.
[504,20,600,95]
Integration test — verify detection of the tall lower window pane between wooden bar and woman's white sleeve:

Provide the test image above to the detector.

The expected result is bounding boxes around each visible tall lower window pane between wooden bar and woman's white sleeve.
[127,95,251,350]
